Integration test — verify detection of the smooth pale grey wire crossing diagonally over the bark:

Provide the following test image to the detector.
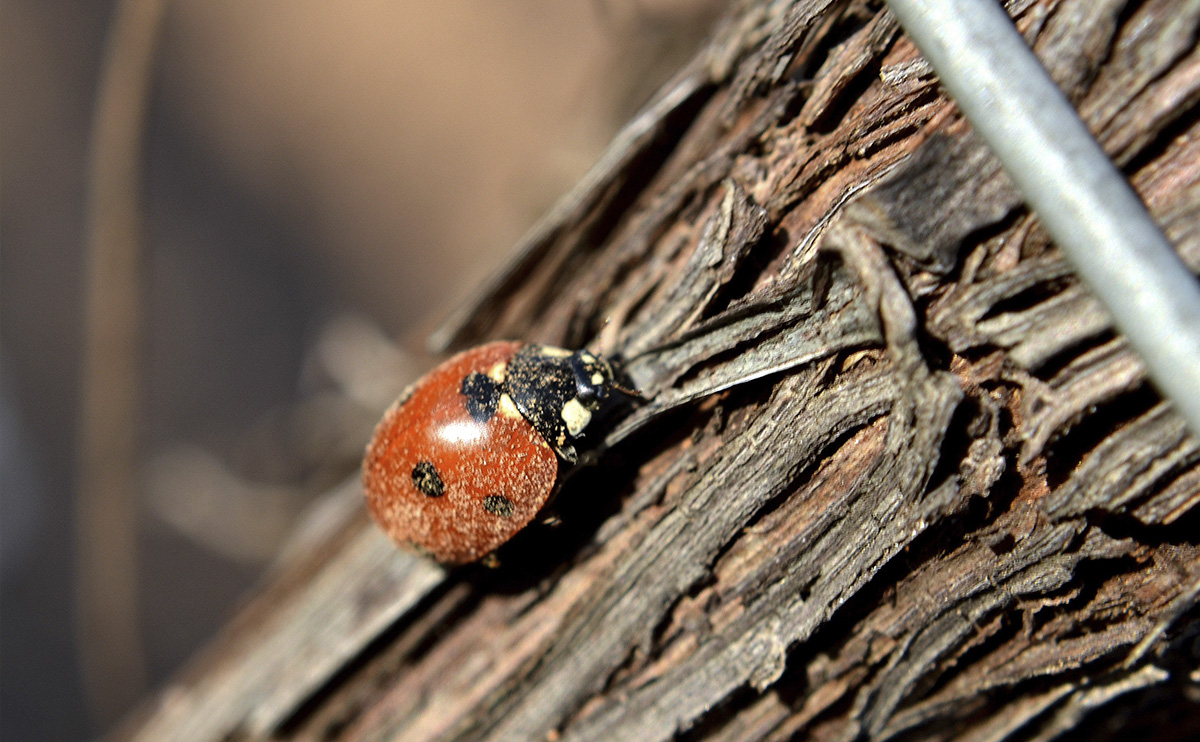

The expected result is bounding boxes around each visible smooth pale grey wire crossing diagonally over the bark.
[888,0,1200,433]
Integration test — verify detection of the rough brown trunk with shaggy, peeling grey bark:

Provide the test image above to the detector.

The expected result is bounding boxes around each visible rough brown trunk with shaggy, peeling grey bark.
[120,0,1200,741]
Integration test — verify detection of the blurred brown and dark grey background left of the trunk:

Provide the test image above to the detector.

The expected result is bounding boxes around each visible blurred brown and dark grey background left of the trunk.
[0,0,724,742]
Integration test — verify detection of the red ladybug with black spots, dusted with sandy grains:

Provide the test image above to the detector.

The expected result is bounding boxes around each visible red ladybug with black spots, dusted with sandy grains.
[362,342,634,564]
